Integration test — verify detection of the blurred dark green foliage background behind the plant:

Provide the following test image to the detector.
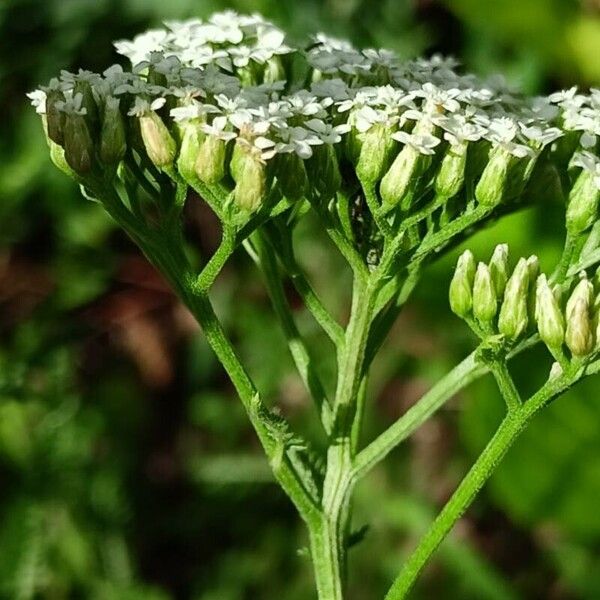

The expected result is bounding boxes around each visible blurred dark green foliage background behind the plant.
[0,0,600,600]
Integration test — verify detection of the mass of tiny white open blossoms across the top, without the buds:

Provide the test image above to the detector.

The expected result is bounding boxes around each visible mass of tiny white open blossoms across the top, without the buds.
[30,12,600,195]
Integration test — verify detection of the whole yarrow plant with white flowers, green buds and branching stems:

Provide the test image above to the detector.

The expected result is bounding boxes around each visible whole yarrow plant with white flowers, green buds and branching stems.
[30,13,600,600]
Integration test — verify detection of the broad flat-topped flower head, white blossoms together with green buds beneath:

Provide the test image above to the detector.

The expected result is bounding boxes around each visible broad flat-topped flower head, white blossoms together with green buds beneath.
[30,12,600,220]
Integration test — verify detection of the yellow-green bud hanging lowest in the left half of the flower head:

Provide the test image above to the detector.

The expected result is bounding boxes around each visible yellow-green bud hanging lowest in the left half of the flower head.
[231,143,267,212]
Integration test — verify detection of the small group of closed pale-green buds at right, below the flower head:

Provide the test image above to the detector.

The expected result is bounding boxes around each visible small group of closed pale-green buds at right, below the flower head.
[450,244,600,358]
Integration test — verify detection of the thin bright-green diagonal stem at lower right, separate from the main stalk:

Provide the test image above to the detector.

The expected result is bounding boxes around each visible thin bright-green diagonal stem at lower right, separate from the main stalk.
[386,373,574,600]
